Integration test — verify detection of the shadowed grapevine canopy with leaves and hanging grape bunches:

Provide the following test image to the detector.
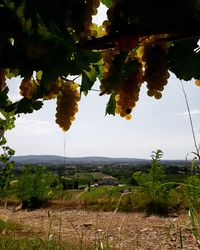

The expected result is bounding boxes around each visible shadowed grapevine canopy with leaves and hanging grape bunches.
[0,0,200,131]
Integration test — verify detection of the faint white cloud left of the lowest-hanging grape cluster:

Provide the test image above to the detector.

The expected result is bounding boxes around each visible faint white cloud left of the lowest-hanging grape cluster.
[13,118,56,136]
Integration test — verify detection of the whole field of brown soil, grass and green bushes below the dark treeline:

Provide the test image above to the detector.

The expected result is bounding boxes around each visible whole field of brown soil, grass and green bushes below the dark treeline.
[0,151,200,250]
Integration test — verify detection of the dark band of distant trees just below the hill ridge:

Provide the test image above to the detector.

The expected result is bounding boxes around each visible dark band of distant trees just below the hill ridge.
[5,161,197,179]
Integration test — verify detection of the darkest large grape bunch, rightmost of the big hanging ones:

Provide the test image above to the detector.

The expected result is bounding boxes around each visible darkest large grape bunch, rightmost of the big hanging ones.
[142,43,169,99]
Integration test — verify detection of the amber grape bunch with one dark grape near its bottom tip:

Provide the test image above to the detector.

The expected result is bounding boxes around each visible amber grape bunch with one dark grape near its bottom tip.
[115,58,144,120]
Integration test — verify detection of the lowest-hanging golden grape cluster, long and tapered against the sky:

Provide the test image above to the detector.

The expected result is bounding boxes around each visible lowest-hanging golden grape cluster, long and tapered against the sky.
[56,80,80,131]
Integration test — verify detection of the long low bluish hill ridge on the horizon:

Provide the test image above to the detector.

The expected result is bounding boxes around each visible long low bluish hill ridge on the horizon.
[11,155,150,164]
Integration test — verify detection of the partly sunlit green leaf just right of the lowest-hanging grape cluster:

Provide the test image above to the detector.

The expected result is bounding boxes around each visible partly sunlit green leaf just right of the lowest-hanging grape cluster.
[80,67,97,95]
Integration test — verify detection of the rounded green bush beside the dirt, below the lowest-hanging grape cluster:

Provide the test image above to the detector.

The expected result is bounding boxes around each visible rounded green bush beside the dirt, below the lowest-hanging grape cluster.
[17,165,59,208]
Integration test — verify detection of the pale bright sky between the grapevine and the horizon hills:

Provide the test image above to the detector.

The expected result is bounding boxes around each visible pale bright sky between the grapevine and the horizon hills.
[2,6,200,159]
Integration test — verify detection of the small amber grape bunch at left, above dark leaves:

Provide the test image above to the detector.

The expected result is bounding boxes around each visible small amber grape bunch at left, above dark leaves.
[19,76,38,99]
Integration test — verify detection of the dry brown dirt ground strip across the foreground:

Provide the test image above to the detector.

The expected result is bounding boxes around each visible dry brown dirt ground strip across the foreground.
[0,205,199,250]
